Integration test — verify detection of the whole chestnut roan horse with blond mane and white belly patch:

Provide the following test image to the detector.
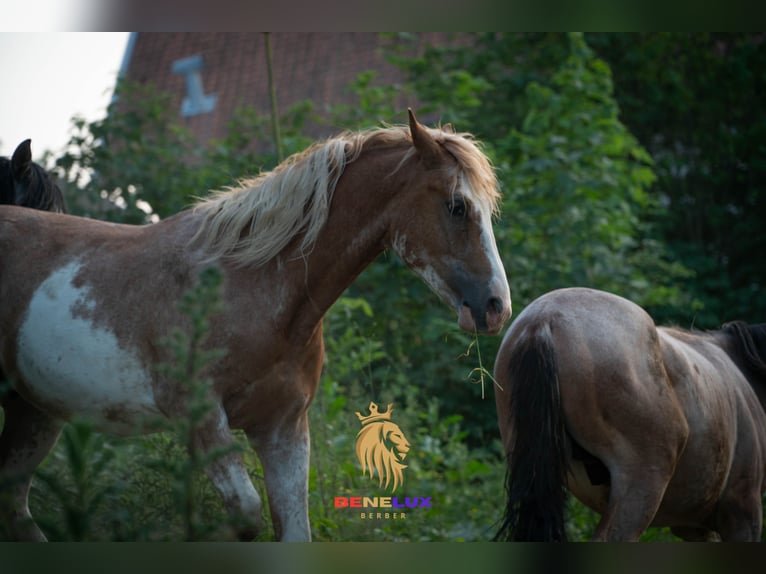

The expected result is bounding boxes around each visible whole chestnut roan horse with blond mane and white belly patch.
[0,112,511,540]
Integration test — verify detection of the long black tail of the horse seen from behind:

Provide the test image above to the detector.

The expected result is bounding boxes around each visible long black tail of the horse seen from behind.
[495,323,566,542]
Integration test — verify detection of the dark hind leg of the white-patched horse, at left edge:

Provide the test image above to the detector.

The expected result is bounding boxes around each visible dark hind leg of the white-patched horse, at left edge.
[0,391,63,542]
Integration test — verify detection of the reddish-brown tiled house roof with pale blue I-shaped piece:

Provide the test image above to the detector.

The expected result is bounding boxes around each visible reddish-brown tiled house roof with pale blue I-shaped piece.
[121,32,445,151]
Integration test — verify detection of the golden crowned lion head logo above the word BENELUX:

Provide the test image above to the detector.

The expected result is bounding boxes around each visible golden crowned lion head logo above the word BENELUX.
[356,402,410,492]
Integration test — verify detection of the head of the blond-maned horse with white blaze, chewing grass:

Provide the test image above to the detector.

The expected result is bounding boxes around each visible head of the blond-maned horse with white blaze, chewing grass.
[390,110,511,334]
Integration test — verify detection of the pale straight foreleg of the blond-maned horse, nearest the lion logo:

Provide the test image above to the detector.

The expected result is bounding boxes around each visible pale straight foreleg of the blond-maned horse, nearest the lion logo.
[251,413,311,542]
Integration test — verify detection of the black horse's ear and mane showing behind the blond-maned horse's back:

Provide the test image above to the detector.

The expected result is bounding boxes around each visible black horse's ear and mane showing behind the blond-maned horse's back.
[0,140,66,213]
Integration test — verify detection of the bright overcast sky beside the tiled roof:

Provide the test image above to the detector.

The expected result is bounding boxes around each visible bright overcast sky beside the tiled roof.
[0,32,128,159]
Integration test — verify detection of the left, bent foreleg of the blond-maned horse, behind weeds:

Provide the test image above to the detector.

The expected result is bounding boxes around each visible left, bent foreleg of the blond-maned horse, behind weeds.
[194,406,263,540]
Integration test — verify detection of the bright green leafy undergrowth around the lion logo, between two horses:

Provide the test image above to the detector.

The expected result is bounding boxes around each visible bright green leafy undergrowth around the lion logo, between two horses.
[309,298,504,541]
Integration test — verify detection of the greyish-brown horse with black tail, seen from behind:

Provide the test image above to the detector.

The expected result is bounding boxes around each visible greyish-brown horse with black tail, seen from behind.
[494,288,766,541]
